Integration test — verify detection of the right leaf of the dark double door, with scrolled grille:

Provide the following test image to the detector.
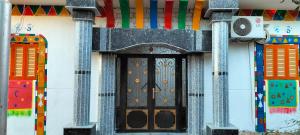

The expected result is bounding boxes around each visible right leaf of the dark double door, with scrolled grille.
[153,58,176,130]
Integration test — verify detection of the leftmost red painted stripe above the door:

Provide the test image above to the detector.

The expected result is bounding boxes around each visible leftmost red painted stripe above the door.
[104,0,115,28]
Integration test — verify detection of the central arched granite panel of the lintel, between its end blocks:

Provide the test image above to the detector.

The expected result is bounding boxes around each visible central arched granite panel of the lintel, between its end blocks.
[109,29,195,51]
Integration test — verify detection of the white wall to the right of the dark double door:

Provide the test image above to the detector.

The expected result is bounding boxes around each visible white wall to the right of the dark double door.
[204,21,300,131]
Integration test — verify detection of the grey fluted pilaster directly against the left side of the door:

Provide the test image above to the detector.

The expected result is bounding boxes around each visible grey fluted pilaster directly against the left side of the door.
[97,54,116,135]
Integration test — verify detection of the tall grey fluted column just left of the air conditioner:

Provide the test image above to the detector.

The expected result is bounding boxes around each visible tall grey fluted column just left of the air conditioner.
[212,12,231,127]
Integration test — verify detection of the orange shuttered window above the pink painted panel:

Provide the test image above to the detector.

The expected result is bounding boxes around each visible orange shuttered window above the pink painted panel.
[10,44,37,80]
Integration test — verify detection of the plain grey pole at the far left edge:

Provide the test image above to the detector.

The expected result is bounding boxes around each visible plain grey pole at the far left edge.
[0,0,11,135]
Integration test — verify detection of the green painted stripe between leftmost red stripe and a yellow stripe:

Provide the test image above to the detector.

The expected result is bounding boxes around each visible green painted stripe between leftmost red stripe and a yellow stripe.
[119,0,130,28]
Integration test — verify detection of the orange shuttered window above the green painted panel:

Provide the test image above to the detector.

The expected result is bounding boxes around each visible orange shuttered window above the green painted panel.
[264,45,298,79]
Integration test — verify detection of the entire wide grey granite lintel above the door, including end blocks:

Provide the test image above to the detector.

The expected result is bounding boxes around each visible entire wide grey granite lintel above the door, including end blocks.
[93,28,211,53]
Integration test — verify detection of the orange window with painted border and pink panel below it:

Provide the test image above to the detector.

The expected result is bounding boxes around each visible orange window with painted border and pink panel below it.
[9,34,48,135]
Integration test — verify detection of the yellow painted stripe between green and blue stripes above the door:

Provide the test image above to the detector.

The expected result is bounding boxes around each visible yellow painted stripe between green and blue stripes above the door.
[135,0,144,29]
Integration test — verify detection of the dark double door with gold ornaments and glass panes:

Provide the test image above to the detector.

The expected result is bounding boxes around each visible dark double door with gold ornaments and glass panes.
[117,55,186,132]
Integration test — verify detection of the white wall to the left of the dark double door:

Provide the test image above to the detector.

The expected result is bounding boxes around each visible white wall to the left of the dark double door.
[8,16,100,135]
